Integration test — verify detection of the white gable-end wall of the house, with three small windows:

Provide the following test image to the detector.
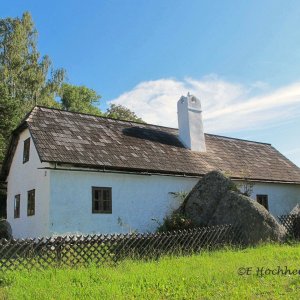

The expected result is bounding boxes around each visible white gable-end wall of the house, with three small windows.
[7,129,50,238]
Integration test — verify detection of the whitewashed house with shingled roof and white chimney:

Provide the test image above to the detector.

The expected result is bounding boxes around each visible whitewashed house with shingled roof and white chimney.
[0,95,300,237]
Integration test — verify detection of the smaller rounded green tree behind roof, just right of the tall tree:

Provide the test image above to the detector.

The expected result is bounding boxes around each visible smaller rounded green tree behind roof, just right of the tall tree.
[59,83,102,116]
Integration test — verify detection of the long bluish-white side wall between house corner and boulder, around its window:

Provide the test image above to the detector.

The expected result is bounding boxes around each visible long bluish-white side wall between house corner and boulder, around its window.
[50,170,197,234]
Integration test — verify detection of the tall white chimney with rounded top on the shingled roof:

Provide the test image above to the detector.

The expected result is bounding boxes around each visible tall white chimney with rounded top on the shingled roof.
[177,93,206,152]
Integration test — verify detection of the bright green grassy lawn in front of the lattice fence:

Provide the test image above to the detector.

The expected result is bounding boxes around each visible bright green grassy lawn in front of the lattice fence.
[0,244,300,299]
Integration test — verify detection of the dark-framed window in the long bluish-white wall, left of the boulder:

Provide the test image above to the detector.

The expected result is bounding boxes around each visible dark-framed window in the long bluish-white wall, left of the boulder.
[92,187,112,214]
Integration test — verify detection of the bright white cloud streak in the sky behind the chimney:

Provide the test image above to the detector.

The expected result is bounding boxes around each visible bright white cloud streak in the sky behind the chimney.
[109,76,300,133]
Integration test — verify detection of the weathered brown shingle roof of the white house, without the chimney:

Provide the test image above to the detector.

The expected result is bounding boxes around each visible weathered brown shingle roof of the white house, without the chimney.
[1,107,300,183]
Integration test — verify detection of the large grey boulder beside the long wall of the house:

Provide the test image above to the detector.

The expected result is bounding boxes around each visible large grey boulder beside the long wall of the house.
[183,171,286,244]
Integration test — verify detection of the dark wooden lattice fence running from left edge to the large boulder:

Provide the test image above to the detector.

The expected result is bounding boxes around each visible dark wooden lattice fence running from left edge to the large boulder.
[0,225,242,271]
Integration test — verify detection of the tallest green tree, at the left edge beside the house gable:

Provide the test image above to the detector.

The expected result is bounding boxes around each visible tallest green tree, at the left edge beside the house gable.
[0,12,65,160]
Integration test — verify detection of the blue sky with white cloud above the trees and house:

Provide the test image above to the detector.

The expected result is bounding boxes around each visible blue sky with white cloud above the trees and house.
[0,0,300,166]
